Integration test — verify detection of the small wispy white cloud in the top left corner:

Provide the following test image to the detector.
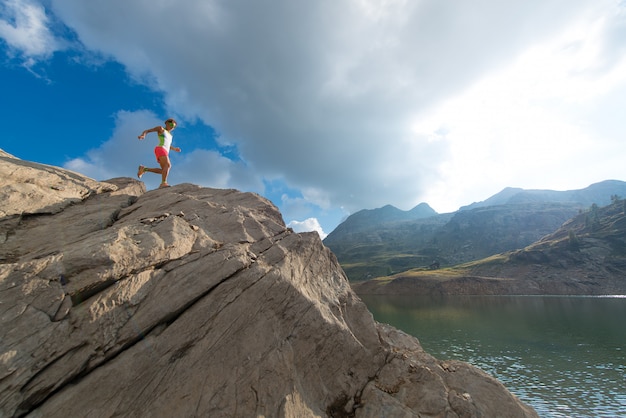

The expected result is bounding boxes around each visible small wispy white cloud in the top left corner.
[0,0,62,59]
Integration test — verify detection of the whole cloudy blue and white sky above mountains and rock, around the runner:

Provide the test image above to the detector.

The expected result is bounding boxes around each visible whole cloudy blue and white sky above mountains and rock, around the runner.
[0,0,626,237]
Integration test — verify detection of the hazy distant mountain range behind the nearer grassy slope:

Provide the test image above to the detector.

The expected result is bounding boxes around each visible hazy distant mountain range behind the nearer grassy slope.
[324,180,626,281]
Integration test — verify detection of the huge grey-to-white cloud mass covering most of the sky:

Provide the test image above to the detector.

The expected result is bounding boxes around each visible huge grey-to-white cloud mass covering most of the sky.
[40,0,625,219]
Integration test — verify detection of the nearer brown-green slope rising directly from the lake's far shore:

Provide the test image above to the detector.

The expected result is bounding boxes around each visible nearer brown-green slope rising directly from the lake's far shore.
[353,198,626,295]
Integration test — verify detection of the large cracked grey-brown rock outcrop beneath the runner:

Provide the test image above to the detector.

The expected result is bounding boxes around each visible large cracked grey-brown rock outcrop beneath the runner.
[0,153,536,418]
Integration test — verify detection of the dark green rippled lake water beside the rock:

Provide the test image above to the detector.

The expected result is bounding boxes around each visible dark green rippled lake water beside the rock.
[362,296,626,417]
